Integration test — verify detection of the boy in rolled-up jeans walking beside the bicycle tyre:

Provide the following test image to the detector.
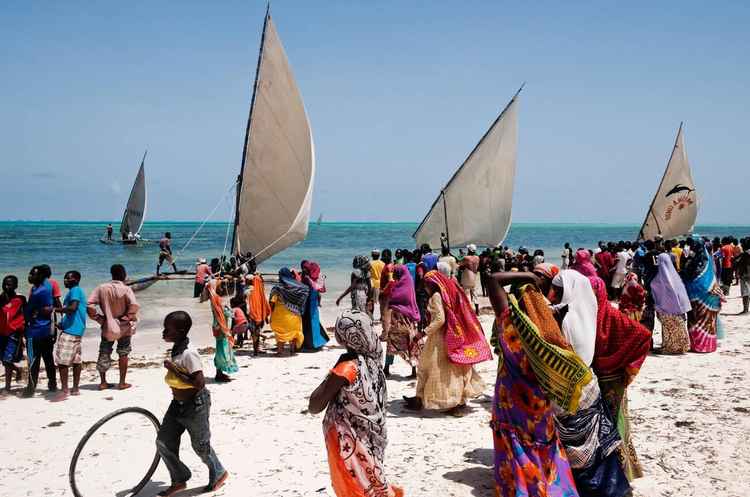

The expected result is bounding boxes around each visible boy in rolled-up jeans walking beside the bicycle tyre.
[156,311,229,496]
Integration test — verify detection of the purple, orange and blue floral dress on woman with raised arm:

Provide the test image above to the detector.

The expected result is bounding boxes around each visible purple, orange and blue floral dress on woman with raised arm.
[491,310,579,497]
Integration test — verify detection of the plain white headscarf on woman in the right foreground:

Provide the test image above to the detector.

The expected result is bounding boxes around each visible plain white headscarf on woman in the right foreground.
[552,269,599,366]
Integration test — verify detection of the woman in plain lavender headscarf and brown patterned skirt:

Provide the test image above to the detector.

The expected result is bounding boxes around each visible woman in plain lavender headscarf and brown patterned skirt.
[651,254,690,354]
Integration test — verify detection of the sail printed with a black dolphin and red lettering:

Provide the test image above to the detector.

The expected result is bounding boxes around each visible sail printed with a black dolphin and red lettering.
[639,123,698,240]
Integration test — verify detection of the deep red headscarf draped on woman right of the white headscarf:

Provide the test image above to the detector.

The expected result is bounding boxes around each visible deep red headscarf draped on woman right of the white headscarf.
[589,277,651,385]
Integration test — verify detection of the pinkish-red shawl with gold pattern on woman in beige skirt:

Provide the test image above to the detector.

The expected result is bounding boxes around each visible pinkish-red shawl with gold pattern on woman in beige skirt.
[424,271,492,364]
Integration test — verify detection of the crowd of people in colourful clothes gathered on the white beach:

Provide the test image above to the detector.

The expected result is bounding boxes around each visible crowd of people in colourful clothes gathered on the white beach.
[0,233,750,497]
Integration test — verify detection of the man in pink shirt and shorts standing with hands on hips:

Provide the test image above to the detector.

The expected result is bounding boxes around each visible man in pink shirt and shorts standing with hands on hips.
[88,264,140,390]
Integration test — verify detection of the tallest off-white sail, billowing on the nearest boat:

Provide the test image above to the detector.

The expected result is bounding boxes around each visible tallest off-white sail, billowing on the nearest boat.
[233,14,315,263]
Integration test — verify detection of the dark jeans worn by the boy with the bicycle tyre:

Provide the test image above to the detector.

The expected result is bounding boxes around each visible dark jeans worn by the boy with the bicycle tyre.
[156,388,225,486]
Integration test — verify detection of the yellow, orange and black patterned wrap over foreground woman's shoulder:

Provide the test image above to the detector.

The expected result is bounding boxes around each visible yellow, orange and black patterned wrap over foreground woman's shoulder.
[512,286,591,413]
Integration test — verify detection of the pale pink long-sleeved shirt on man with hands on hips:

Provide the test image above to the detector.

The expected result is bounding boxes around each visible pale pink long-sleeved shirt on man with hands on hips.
[87,281,140,341]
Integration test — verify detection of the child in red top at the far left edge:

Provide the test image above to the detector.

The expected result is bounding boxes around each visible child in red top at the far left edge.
[0,274,26,393]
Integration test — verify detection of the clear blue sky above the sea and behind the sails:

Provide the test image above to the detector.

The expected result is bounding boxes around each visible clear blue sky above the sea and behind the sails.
[0,0,750,224]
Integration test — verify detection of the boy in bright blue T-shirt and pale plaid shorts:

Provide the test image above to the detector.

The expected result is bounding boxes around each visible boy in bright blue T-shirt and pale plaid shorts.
[53,271,87,401]
